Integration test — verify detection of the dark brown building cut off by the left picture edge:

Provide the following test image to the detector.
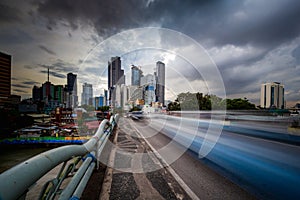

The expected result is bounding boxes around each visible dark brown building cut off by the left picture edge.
[0,52,11,98]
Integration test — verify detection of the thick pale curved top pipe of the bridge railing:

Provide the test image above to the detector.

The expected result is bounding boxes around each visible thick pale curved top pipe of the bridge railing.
[0,115,118,200]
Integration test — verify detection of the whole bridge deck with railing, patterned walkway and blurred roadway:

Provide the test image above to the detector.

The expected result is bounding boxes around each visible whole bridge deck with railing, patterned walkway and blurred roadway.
[0,111,300,199]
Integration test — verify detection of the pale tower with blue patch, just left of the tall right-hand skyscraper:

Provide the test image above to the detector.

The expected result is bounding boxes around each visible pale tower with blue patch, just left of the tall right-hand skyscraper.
[141,74,156,105]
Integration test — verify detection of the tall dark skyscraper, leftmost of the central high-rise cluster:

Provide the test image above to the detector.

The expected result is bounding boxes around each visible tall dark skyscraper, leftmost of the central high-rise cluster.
[108,57,125,105]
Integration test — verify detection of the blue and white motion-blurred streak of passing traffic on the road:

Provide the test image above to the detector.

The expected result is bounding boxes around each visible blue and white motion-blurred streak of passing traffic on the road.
[146,115,300,199]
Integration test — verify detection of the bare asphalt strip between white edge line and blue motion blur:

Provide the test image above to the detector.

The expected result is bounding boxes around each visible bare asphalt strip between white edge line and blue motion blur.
[128,116,255,199]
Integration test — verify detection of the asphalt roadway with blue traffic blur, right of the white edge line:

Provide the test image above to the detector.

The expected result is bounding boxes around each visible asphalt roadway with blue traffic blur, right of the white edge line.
[129,116,300,199]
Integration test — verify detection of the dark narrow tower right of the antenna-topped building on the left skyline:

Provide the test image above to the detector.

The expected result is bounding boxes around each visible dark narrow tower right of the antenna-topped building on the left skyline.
[67,73,78,108]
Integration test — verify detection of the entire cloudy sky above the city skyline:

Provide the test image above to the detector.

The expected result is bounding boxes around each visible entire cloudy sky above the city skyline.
[0,0,300,105]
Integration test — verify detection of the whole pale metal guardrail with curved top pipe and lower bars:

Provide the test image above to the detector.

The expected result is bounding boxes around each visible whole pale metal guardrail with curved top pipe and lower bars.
[0,115,118,200]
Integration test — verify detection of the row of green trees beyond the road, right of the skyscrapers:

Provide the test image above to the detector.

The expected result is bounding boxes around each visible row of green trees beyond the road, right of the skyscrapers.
[168,92,255,111]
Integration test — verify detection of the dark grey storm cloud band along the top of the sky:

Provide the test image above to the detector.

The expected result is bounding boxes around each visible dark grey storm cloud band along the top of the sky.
[38,0,300,46]
